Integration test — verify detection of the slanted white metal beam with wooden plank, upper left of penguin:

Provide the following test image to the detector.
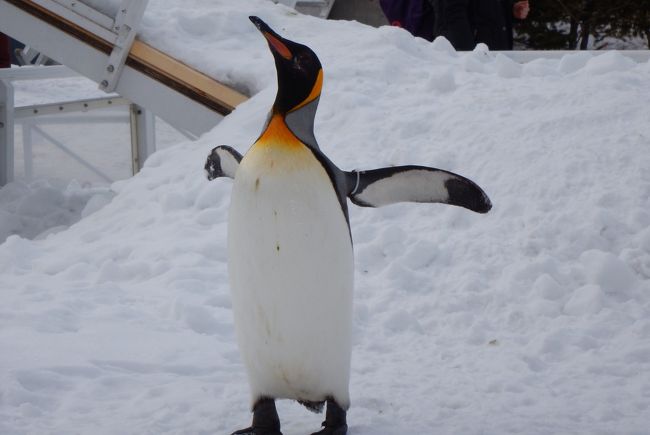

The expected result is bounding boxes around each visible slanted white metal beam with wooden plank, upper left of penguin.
[0,0,247,186]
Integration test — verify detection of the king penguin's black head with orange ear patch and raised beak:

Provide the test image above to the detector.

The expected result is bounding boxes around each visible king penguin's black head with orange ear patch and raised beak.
[249,17,323,115]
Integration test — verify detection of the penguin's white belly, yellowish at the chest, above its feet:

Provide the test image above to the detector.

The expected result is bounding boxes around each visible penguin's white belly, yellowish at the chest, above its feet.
[228,140,354,409]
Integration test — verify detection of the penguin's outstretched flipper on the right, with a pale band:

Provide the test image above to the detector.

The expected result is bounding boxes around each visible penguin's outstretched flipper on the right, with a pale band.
[345,165,492,213]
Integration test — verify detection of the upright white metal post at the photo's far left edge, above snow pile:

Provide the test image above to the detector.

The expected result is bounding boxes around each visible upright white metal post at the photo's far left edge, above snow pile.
[0,80,14,186]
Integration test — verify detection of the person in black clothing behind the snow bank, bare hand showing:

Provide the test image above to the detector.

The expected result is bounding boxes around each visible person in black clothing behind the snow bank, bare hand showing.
[427,0,530,50]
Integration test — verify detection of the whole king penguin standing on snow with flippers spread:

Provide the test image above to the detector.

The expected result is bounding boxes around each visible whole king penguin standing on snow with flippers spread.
[205,17,491,435]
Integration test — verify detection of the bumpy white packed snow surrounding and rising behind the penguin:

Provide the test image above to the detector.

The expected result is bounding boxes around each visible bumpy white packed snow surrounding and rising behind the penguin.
[0,0,650,435]
